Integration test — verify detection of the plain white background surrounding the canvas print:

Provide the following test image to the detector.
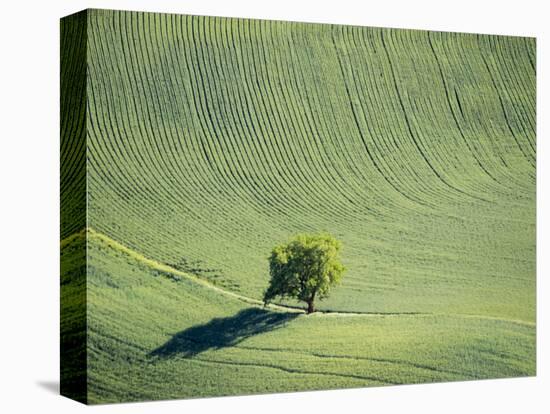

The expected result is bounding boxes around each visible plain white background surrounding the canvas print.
[0,0,550,414]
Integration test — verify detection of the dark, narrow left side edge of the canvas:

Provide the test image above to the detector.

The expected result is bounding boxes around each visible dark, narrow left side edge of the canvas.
[60,10,88,403]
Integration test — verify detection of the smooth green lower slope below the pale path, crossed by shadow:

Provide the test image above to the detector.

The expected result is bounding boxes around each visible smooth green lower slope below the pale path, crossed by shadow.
[72,232,535,403]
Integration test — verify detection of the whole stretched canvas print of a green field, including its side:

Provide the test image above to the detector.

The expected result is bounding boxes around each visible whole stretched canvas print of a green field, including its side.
[61,10,536,404]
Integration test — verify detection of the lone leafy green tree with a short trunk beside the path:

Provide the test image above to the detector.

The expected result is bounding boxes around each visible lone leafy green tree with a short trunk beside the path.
[264,233,345,313]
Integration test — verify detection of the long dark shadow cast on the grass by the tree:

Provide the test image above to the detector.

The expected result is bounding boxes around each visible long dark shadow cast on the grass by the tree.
[149,308,299,358]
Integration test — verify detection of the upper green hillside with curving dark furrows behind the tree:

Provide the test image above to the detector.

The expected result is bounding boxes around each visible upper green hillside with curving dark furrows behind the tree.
[84,11,535,321]
